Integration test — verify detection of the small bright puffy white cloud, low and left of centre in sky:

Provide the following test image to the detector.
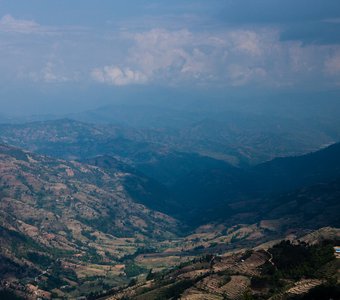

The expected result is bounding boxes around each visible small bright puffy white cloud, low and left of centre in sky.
[91,66,147,86]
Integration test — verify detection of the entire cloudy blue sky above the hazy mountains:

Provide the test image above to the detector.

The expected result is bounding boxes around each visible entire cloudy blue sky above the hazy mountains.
[0,0,340,114]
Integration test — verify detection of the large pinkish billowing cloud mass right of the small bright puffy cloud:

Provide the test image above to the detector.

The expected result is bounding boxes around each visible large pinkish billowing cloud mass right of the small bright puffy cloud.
[127,28,278,85]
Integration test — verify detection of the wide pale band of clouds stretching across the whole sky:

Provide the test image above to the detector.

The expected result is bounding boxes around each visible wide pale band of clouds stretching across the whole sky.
[0,15,340,87]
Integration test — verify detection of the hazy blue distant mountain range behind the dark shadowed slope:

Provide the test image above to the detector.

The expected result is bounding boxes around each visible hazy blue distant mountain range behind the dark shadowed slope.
[0,115,334,166]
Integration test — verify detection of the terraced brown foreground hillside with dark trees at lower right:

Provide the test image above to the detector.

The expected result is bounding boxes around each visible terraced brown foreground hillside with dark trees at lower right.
[95,228,340,300]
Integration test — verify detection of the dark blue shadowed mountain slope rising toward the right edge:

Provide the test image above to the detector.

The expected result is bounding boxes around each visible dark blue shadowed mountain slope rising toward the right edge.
[136,143,340,225]
